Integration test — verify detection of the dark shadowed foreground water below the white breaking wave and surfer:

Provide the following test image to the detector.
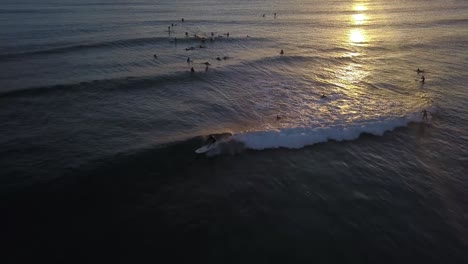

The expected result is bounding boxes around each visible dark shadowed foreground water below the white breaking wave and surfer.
[1,127,464,263]
